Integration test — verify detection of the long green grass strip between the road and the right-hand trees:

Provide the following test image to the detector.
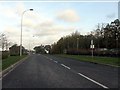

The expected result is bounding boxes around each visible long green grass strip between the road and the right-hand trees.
[59,55,120,66]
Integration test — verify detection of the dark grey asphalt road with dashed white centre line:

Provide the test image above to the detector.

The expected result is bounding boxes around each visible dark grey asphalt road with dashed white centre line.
[2,54,118,88]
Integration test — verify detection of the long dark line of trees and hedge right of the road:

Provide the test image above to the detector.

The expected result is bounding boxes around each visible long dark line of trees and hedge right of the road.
[51,19,120,56]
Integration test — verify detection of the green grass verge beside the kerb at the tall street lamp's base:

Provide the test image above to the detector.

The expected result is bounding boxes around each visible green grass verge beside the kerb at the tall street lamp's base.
[2,55,27,70]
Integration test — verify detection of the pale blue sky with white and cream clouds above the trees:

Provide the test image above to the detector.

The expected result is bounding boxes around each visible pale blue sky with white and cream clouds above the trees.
[0,1,118,49]
